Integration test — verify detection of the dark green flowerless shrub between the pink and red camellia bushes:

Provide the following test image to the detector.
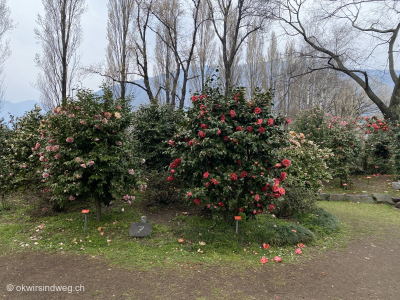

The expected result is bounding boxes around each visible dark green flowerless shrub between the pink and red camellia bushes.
[132,105,183,170]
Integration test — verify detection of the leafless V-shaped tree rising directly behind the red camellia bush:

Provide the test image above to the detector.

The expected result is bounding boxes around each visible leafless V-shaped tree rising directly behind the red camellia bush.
[207,0,266,93]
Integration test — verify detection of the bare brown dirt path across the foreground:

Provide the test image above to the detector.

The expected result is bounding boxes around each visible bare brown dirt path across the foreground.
[0,232,400,300]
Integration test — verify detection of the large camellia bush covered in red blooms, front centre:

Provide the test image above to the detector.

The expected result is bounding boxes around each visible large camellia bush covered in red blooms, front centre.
[166,88,291,220]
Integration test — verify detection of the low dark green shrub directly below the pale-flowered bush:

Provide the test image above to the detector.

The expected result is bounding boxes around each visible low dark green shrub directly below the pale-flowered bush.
[273,186,317,218]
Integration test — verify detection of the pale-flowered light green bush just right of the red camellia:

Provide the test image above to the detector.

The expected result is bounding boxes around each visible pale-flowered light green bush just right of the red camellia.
[282,131,335,192]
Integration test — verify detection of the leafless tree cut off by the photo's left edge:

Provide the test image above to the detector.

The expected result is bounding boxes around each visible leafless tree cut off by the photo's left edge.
[0,0,14,108]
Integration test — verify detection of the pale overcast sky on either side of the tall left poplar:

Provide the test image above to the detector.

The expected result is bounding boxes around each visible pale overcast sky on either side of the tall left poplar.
[4,0,108,102]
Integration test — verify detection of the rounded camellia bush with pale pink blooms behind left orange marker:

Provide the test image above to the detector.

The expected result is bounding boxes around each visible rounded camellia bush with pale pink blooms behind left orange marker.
[34,89,136,220]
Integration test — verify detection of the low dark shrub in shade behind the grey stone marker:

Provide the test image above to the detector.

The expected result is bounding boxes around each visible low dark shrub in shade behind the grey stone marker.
[143,170,183,205]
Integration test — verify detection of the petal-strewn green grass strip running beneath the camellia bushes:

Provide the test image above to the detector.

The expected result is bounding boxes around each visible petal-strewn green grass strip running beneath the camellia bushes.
[0,192,400,270]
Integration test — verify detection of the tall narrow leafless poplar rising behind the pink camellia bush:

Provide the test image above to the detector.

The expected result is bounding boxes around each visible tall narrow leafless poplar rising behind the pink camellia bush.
[35,0,86,108]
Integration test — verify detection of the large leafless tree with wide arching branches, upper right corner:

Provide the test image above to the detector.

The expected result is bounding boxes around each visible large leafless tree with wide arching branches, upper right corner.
[258,0,400,119]
